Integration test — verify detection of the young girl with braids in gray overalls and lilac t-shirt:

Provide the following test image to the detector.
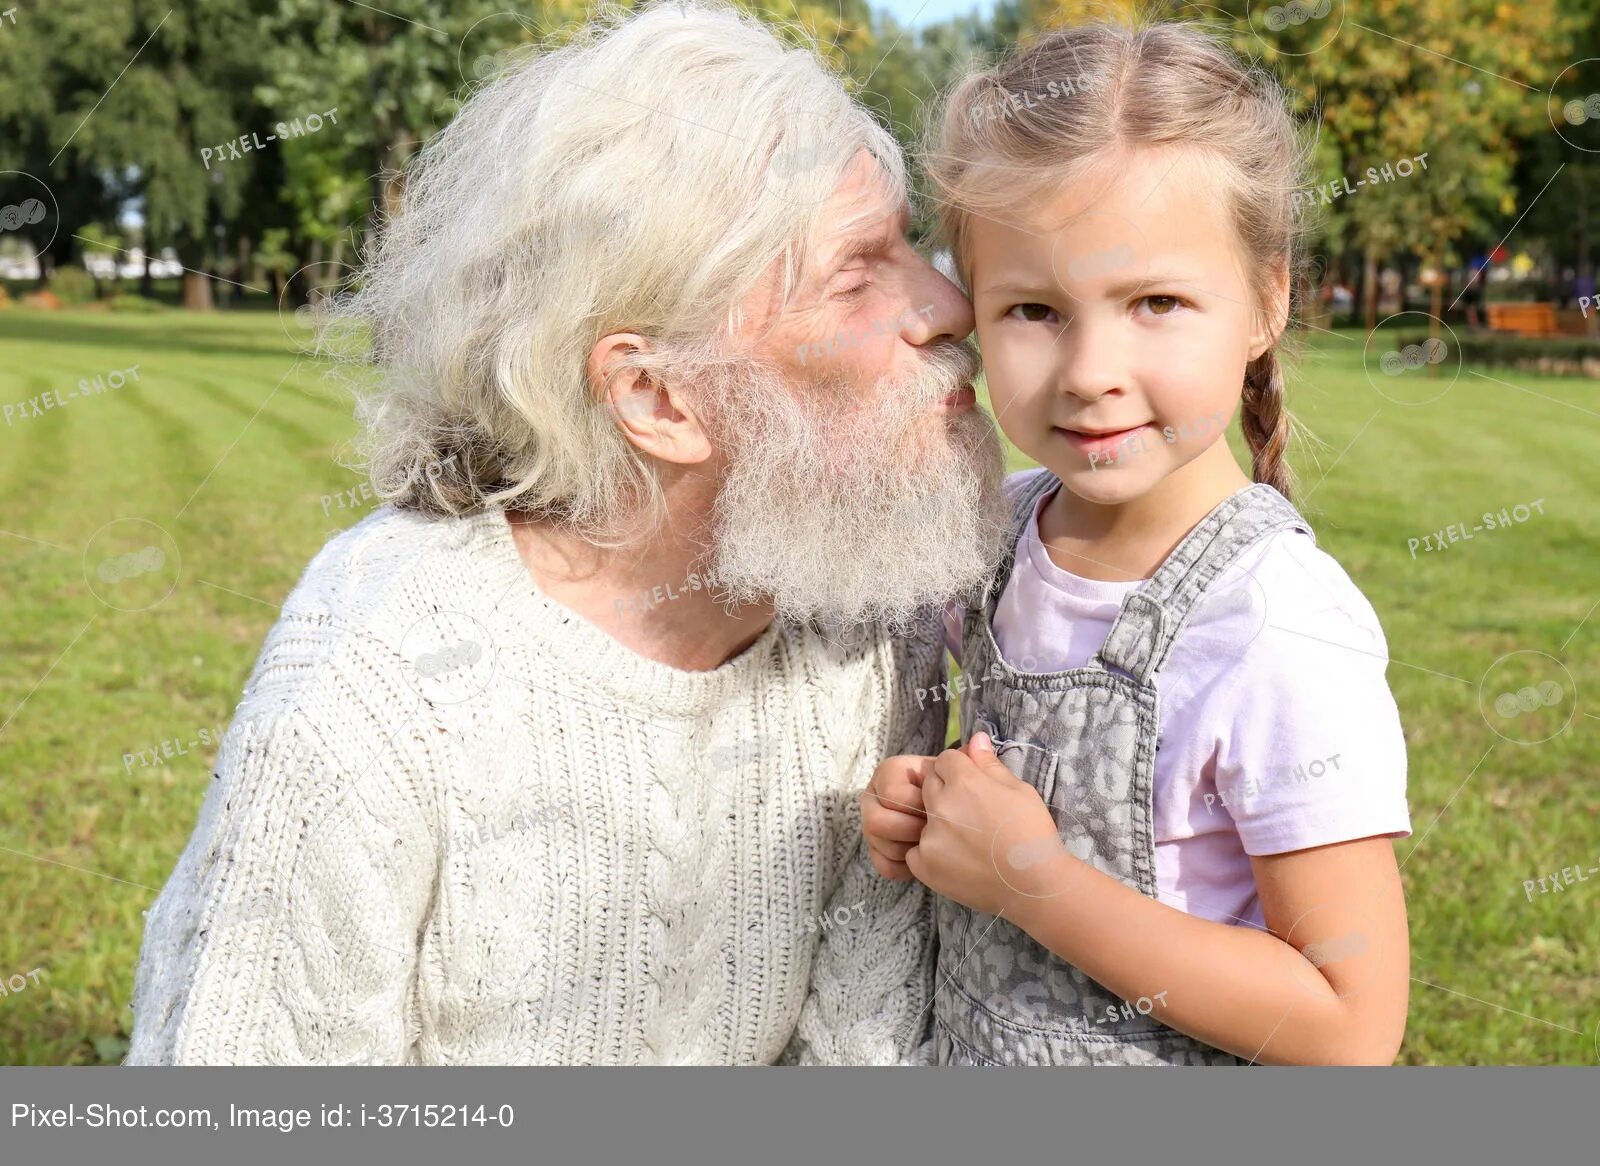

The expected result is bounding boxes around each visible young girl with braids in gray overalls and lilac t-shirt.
[862,24,1410,1065]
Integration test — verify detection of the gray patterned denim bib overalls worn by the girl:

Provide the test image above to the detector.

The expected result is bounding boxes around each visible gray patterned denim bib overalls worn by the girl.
[933,473,1310,1065]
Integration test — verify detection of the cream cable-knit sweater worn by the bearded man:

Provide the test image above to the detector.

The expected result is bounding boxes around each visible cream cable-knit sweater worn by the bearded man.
[125,507,944,1065]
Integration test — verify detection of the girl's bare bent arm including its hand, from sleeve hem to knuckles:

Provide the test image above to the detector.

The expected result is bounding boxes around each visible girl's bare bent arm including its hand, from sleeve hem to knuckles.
[906,734,1410,1064]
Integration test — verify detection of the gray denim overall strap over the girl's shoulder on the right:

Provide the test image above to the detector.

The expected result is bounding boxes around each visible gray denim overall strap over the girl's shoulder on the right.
[1094,483,1317,683]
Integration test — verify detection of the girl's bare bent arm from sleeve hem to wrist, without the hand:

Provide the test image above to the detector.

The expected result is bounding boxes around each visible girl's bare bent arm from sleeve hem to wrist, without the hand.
[1006,838,1410,1065]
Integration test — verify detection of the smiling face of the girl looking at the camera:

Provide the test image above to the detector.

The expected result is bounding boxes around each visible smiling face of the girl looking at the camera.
[970,149,1286,505]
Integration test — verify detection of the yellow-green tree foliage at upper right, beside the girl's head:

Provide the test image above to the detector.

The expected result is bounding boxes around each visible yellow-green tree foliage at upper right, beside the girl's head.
[1024,0,1600,300]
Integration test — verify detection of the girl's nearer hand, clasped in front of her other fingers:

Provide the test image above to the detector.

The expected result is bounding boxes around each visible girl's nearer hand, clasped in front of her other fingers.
[906,733,1077,916]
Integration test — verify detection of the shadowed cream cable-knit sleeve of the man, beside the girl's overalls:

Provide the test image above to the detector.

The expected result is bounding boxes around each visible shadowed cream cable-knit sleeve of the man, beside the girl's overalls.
[778,619,947,1065]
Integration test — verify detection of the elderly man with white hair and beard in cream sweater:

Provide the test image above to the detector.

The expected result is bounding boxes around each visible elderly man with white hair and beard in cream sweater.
[126,5,1000,1064]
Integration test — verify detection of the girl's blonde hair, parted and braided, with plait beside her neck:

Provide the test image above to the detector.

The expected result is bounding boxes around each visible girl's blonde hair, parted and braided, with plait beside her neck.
[926,21,1307,496]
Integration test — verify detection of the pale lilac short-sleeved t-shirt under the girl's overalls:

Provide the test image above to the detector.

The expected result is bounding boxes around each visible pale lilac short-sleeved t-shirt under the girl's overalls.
[946,470,1411,926]
